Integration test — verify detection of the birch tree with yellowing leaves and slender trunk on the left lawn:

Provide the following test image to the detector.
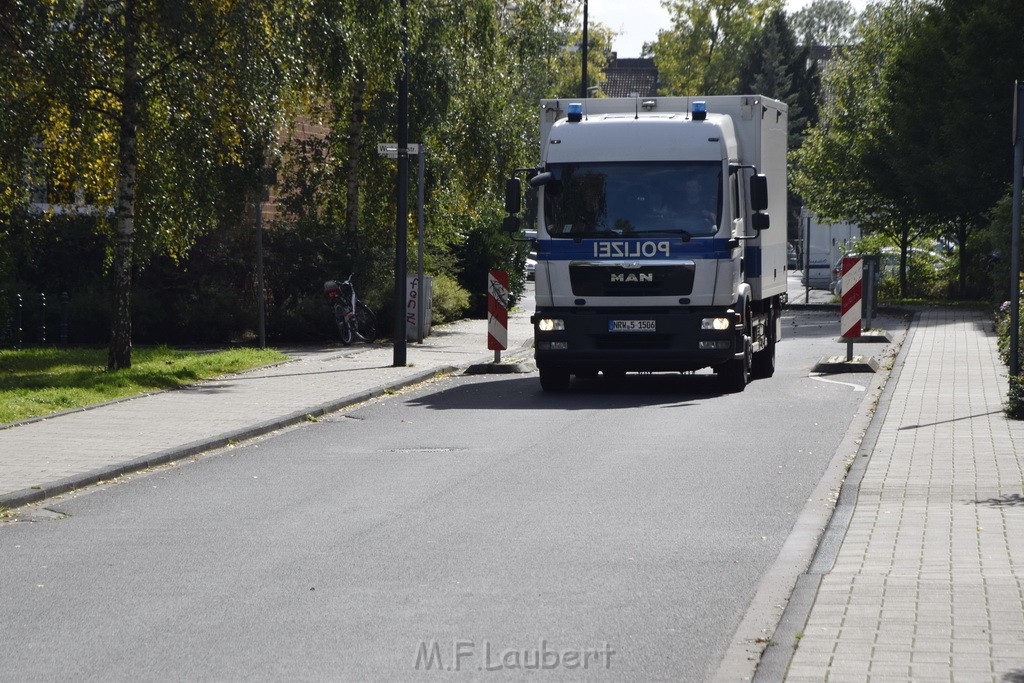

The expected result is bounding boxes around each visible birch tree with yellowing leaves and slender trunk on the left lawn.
[0,0,301,370]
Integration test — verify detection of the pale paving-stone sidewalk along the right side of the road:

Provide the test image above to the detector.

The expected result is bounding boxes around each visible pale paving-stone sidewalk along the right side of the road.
[786,309,1024,683]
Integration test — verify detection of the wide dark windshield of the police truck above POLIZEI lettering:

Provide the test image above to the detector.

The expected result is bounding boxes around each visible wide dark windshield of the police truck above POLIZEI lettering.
[544,162,722,239]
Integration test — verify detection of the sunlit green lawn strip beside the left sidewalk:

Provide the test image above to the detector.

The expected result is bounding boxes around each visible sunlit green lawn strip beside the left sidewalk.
[0,346,288,424]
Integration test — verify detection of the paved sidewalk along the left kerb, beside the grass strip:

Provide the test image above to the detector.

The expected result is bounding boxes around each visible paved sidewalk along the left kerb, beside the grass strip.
[0,303,532,508]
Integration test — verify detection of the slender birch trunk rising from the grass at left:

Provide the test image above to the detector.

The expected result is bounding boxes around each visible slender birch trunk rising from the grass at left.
[106,0,142,371]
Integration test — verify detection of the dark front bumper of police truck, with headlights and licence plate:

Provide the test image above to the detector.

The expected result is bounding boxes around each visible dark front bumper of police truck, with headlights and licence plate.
[530,308,743,372]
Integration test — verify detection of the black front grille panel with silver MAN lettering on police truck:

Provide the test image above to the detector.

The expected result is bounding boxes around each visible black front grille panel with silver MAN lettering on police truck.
[569,261,694,297]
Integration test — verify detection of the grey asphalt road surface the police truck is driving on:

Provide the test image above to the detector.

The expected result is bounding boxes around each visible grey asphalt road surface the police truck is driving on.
[0,313,897,680]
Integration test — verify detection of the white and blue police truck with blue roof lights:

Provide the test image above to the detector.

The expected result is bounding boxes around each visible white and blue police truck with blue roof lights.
[506,95,787,392]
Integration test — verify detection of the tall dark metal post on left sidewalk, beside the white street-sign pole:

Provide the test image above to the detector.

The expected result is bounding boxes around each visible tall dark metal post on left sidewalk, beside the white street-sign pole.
[392,0,409,368]
